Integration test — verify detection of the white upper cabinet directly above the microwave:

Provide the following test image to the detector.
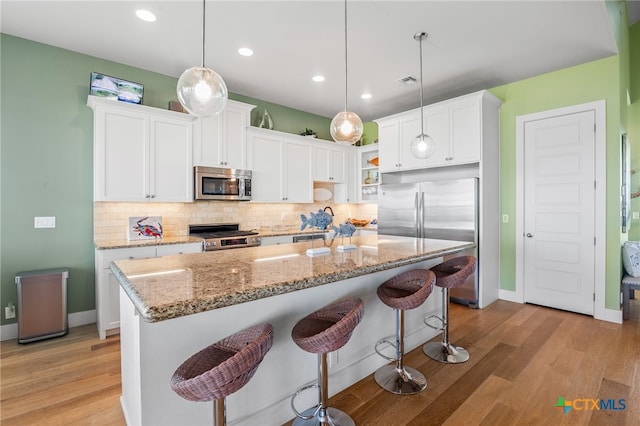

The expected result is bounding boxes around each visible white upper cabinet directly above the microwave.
[193,99,255,169]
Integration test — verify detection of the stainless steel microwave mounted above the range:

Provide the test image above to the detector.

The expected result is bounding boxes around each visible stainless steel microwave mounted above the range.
[194,166,251,201]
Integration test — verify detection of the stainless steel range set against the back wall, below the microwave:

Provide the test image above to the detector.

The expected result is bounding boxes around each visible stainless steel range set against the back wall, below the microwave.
[189,223,261,251]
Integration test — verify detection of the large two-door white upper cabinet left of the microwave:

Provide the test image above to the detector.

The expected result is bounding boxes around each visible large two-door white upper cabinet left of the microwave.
[87,96,194,202]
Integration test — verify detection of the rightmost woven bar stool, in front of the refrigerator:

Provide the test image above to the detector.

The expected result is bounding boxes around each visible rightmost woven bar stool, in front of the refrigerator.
[422,256,476,364]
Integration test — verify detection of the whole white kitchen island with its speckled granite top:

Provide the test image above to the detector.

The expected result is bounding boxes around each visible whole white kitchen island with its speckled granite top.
[111,235,473,425]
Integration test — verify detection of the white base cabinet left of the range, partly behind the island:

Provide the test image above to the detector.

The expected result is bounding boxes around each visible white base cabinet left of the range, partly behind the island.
[95,243,202,339]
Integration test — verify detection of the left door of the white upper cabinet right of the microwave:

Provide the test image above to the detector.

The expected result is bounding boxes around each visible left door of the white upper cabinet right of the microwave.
[249,135,284,202]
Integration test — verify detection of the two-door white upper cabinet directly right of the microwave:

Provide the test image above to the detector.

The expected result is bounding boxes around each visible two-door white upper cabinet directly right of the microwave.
[248,127,313,203]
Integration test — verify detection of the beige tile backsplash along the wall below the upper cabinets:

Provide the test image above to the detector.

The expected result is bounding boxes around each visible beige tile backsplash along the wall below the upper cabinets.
[93,201,378,241]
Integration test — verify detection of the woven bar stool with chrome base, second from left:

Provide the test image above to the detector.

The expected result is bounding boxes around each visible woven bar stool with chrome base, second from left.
[291,298,364,426]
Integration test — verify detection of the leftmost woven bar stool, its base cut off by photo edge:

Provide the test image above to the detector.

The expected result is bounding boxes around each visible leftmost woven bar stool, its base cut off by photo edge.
[171,323,273,426]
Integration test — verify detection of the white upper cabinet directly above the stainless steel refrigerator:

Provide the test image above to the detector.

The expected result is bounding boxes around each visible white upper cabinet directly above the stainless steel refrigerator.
[375,91,502,172]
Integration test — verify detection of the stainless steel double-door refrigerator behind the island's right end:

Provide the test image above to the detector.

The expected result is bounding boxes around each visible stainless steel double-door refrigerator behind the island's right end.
[378,178,480,308]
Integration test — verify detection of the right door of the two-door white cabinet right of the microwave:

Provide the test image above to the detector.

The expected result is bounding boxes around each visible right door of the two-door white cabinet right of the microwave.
[286,142,313,203]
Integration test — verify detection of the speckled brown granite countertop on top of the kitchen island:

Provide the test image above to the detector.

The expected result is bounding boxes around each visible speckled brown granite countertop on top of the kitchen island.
[111,235,474,322]
